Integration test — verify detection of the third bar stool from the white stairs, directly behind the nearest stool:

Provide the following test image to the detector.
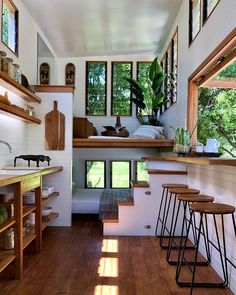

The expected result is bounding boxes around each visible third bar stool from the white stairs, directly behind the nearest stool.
[166,194,214,265]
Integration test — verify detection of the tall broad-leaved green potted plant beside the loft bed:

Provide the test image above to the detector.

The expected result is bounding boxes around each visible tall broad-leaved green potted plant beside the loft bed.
[127,57,167,125]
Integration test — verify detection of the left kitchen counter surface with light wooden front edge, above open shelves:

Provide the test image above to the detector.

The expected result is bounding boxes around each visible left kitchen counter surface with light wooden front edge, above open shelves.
[0,166,63,186]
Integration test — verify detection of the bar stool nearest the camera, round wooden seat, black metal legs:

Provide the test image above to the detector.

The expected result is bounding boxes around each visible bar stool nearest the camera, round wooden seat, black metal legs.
[176,203,236,295]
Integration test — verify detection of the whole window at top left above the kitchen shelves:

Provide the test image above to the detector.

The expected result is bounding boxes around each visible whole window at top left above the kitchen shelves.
[2,0,18,54]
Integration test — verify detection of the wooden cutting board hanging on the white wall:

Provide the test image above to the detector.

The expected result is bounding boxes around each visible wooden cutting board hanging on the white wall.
[45,100,65,150]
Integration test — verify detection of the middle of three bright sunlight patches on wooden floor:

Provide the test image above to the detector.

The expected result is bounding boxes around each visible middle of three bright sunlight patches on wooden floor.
[98,257,118,278]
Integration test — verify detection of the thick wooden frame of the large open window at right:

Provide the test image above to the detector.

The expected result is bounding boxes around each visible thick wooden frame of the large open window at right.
[187,28,236,143]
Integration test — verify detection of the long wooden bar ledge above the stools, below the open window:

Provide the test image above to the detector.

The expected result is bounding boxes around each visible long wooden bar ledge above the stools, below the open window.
[142,156,236,166]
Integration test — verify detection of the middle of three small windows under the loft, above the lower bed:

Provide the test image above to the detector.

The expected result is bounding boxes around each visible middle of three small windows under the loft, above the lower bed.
[111,161,131,188]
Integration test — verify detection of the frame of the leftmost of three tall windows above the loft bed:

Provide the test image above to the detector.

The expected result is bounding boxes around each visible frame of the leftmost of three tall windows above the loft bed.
[85,60,107,117]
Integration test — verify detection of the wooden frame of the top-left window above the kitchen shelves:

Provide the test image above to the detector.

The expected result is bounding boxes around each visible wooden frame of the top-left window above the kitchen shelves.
[1,0,19,57]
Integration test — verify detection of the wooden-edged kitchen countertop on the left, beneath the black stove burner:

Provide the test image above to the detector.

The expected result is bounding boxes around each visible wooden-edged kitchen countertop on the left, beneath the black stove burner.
[0,166,63,186]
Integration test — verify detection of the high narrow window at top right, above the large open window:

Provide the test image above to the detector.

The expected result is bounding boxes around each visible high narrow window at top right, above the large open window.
[189,0,220,44]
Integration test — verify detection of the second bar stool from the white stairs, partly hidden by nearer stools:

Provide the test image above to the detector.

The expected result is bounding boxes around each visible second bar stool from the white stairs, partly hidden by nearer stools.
[160,188,200,249]
